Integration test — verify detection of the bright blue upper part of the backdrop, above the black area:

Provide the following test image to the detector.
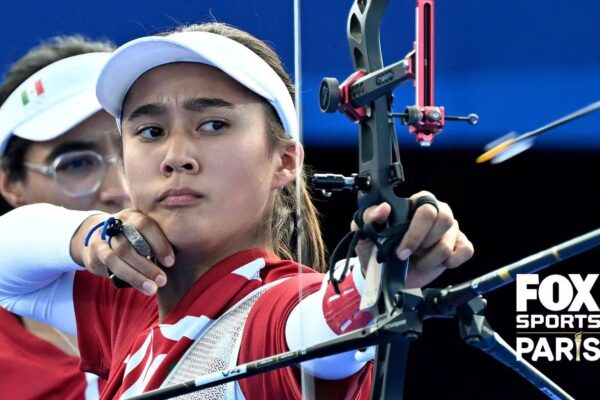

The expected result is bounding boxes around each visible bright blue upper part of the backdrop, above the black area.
[0,0,600,150]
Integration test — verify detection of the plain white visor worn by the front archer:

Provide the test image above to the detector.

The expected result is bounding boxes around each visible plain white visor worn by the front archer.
[96,32,299,138]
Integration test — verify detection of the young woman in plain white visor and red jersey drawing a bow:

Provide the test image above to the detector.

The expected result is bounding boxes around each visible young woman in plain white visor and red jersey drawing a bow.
[0,23,473,399]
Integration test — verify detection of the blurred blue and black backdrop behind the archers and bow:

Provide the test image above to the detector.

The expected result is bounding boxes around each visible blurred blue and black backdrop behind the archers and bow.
[0,0,600,399]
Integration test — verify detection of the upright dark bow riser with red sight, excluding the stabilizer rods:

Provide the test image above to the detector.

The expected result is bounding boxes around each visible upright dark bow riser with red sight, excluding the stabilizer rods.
[313,0,478,399]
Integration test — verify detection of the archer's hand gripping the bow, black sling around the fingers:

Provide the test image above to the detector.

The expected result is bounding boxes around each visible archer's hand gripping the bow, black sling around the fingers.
[351,191,474,288]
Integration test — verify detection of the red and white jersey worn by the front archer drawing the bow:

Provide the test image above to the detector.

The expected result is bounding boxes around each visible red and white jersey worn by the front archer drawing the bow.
[74,249,371,399]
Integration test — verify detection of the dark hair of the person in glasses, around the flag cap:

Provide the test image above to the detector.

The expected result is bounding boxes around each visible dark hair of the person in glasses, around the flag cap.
[0,35,115,181]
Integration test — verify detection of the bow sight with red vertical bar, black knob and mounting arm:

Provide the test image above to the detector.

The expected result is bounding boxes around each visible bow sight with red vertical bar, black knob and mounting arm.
[319,0,479,143]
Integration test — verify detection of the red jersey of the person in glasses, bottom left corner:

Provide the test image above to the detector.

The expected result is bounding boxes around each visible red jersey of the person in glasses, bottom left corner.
[0,308,98,400]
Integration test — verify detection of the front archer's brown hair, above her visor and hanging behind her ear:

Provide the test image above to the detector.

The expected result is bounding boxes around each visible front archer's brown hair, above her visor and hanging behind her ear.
[169,22,327,271]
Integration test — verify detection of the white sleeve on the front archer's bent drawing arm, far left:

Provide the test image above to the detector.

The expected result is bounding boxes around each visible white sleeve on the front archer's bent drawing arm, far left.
[0,204,101,334]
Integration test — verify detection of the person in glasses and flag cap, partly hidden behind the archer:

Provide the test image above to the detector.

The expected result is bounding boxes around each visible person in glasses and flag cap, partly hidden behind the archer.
[0,36,128,399]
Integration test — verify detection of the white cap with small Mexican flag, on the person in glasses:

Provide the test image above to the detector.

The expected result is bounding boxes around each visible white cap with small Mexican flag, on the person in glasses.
[0,53,110,155]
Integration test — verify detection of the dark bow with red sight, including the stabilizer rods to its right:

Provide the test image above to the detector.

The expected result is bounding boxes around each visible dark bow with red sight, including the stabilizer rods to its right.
[313,0,588,400]
